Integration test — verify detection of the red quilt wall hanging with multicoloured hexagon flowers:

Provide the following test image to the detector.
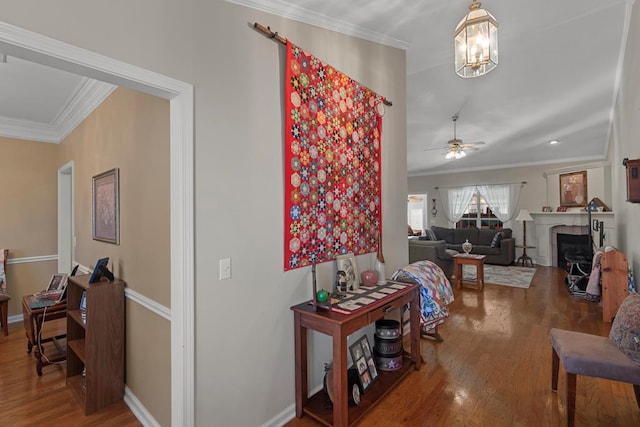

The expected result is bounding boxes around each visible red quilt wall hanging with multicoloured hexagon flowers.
[284,41,384,270]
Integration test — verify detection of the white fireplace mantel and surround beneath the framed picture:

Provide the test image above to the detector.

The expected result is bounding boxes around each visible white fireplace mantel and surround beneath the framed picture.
[531,212,616,266]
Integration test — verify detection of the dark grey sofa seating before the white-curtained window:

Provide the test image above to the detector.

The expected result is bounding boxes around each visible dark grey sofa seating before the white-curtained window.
[409,226,516,277]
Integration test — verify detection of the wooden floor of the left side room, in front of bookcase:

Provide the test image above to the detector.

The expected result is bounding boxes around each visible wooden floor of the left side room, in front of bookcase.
[0,319,142,427]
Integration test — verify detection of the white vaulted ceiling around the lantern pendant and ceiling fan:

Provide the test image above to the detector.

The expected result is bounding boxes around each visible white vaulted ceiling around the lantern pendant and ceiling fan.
[228,0,633,176]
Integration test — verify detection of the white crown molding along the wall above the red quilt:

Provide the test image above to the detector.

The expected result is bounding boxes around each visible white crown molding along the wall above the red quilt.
[225,0,411,50]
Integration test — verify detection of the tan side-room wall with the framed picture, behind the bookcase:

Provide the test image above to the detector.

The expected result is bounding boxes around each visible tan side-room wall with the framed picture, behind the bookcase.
[59,88,171,425]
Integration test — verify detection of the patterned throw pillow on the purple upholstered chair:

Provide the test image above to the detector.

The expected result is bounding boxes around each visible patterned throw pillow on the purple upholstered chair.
[609,292,640,365]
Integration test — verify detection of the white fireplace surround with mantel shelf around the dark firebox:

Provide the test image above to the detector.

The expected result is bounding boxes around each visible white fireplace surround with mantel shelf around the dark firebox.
[528,212,616,266]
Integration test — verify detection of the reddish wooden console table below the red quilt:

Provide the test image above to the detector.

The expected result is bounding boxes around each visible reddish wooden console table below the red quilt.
[291,284,422,427]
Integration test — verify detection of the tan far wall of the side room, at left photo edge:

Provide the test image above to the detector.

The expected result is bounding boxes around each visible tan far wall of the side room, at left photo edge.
[0,138,58,316]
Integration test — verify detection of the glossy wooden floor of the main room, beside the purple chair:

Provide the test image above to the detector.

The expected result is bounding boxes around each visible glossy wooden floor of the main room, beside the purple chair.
[287,267,640,427]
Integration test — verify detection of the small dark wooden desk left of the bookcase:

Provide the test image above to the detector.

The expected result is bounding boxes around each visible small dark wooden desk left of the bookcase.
[22,295,67,376]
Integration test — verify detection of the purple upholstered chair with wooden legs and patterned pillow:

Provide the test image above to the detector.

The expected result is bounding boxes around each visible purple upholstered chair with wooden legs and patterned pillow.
[549,292,640,427]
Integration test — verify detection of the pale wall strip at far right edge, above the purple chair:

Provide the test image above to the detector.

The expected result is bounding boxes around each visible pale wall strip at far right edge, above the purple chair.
[610,2,640,276]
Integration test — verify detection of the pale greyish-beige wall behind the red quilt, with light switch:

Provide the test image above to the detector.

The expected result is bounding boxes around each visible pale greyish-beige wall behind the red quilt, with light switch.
[0,0,407,426]
